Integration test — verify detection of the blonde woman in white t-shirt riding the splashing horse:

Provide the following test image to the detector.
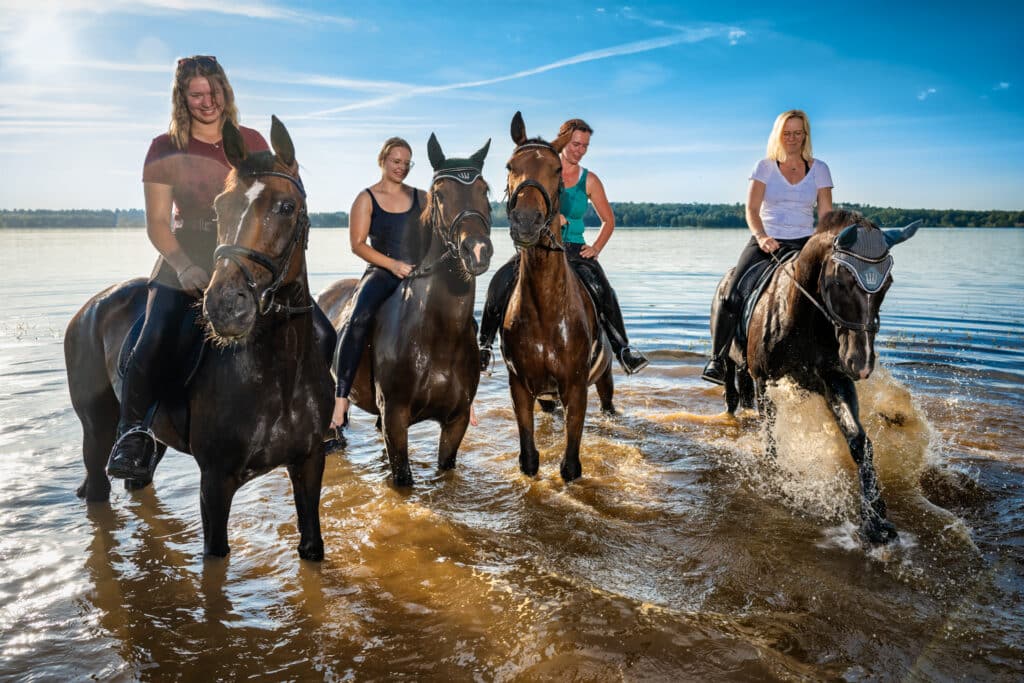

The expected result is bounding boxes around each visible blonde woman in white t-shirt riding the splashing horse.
[700,110,833,384]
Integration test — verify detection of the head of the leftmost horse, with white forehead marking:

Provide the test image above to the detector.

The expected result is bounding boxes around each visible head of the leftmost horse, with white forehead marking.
[203,117,311,344]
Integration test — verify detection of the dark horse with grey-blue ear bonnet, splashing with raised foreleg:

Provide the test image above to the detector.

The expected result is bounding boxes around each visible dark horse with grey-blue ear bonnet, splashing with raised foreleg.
[713,209,920,544]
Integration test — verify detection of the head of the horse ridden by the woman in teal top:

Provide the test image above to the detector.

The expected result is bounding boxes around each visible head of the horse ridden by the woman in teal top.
[505,112,570,249]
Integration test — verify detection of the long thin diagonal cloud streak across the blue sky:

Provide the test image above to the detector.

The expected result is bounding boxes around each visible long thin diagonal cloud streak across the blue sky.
[299,27,732,118]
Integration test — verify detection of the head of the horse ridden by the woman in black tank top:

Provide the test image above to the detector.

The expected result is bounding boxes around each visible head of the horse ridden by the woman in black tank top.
[424,133,495,278]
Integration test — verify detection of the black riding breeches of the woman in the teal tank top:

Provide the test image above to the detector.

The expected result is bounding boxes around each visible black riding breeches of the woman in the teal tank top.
[480,243,630,355]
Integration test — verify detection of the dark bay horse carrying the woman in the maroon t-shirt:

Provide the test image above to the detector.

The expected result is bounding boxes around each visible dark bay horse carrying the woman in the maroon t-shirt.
[65,117,333,560]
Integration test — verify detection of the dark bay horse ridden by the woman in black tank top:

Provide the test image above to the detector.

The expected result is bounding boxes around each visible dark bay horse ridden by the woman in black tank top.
[318,134,494,486]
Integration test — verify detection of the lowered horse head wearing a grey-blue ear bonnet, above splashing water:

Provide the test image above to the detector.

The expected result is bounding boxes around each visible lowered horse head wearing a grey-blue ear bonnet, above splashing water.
[818,209,921,380]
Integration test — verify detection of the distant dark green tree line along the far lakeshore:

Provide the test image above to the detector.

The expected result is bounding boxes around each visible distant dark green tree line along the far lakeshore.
[0,202,1024,228]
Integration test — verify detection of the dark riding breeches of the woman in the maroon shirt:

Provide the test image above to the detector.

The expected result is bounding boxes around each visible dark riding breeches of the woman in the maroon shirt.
[120,283,196,432]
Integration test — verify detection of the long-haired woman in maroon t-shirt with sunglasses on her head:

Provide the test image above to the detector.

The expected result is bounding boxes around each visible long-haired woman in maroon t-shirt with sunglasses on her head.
[106,55,268,482]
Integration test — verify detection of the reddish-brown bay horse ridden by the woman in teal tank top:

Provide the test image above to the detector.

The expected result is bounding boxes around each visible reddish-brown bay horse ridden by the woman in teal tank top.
[501,112,614,481]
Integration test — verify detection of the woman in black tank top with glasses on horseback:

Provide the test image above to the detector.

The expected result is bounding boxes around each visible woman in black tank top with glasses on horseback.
[331,137,426,427]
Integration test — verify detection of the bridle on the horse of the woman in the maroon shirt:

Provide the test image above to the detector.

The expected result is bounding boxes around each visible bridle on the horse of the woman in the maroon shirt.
[213,166,313,315]
